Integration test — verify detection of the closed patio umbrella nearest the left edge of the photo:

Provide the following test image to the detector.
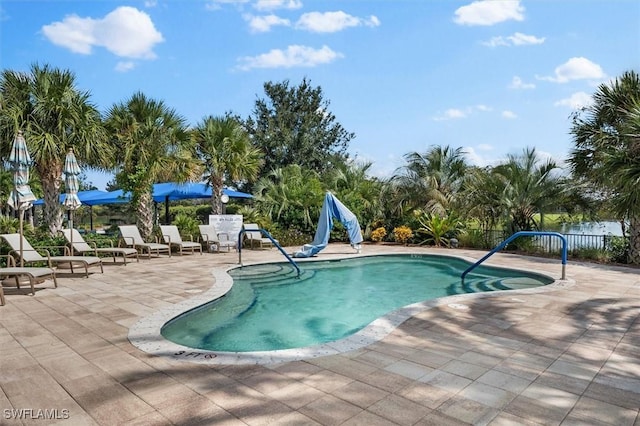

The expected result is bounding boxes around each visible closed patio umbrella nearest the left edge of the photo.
[7,131,36,266]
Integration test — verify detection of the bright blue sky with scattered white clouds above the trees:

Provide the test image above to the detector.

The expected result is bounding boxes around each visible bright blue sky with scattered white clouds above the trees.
[0,0,640,189]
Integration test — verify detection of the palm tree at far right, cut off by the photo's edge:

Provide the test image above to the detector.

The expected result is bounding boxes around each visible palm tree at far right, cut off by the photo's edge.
[568,71,640,264]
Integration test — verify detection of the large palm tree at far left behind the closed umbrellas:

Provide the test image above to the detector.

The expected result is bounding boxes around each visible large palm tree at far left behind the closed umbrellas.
[0,65,113,234]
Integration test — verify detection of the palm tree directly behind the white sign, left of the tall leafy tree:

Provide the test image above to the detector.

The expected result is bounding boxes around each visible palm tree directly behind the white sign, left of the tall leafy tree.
[193,115,262,214]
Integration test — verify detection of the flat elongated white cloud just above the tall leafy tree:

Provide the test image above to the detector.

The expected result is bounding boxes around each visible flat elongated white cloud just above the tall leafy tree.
[238,45,342,71]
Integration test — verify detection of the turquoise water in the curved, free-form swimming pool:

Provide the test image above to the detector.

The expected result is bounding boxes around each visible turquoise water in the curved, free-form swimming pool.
[161,255,553,352]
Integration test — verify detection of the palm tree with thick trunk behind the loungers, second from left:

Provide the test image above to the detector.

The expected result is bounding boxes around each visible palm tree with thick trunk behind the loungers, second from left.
[105,92,201,238]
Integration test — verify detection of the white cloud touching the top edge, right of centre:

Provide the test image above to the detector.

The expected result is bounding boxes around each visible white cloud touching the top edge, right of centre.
[453,0,524,25]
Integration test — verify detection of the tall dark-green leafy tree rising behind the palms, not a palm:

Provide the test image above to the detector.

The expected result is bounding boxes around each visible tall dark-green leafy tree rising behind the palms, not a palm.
[246,78,355,175]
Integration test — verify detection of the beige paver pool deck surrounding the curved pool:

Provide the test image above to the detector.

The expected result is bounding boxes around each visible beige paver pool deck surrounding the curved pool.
[0,244,640,426]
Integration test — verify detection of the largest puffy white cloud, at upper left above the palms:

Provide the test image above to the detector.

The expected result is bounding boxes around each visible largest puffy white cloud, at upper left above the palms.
[42,6,164,59]
